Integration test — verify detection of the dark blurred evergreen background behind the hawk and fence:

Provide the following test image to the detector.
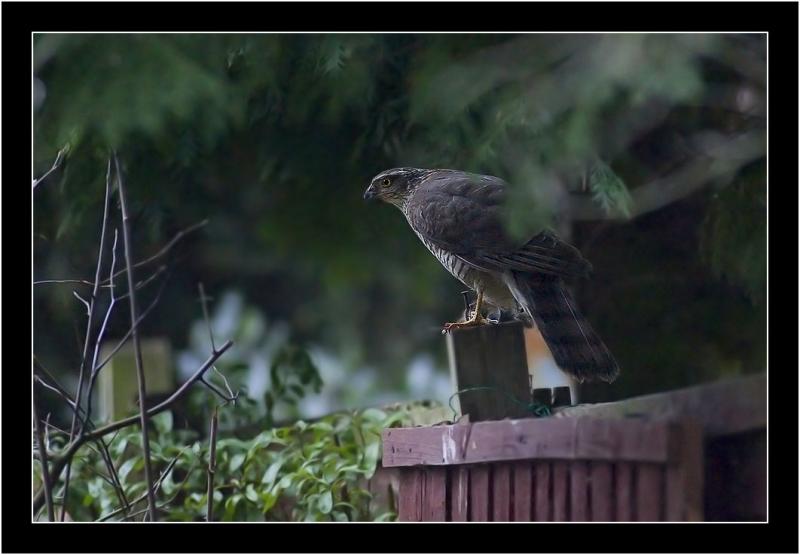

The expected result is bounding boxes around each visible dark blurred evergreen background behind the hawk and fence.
[33,34,767,428]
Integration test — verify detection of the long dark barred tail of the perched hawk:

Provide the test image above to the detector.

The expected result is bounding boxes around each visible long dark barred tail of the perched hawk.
[509,272,619,382]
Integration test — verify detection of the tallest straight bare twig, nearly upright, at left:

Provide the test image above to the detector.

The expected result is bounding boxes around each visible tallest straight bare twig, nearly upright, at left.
[114,152,158,522]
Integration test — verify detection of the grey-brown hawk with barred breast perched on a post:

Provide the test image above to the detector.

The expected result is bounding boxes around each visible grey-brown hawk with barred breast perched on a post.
[364,168,619,382]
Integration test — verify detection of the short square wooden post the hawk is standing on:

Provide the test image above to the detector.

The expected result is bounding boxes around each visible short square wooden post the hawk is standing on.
[447,322,531,422]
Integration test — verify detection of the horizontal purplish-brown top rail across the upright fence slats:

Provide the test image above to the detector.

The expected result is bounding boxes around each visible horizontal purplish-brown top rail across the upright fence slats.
[383,418,670,467]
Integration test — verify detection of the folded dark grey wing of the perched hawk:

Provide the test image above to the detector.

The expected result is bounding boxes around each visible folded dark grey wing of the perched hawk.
[406,171,591,277]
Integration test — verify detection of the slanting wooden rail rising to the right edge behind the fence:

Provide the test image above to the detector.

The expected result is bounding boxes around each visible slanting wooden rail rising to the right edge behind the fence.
[553,374,767,438]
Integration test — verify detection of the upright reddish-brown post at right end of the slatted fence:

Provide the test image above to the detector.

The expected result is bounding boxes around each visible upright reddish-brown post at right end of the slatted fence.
[665,422,703,522]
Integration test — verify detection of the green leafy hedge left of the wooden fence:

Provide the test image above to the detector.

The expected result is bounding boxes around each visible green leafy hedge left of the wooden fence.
[51,347,408,521]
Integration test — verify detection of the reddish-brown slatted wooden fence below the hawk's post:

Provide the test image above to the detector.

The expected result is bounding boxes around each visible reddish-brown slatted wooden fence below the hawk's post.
[383,375,766,521]
